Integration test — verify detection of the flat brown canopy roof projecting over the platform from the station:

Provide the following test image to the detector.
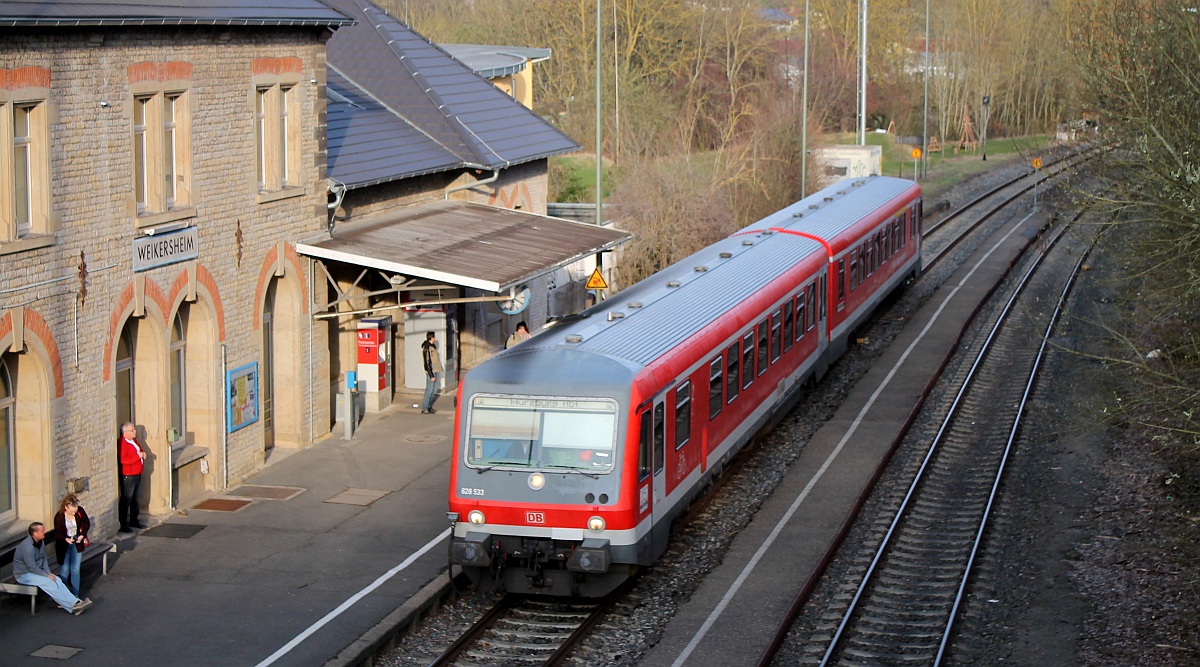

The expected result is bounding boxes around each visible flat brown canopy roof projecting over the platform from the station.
[296,200,630,293]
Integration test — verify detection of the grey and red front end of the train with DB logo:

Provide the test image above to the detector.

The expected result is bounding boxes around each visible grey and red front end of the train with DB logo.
[449,386,649,597]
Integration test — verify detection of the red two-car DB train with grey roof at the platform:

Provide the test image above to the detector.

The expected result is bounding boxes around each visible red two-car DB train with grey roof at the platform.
[449,176,920,596]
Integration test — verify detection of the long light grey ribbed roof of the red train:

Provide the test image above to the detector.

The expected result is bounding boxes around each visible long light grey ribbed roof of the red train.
[497,176,916,366]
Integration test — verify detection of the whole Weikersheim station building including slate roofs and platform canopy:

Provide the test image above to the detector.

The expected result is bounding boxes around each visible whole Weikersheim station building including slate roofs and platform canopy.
[0,0,625,552]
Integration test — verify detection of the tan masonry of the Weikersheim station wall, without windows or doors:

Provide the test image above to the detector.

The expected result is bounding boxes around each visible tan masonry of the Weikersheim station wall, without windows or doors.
[0,28,329,537]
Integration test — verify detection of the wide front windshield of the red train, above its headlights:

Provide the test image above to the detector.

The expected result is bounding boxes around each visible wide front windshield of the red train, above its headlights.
[467,396,617,473]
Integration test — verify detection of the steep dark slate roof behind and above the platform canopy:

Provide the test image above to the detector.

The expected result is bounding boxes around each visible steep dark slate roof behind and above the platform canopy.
[325,0,580,188]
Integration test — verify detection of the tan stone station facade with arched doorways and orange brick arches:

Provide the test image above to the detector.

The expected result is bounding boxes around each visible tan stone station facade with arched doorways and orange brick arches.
[0,26,331,546]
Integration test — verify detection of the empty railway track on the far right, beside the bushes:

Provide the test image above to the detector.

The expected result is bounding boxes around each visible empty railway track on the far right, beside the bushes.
[782,207,1099,666]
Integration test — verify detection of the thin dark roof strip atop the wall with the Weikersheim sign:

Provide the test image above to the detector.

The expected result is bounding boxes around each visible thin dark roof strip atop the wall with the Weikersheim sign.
[0,0,352,26]
